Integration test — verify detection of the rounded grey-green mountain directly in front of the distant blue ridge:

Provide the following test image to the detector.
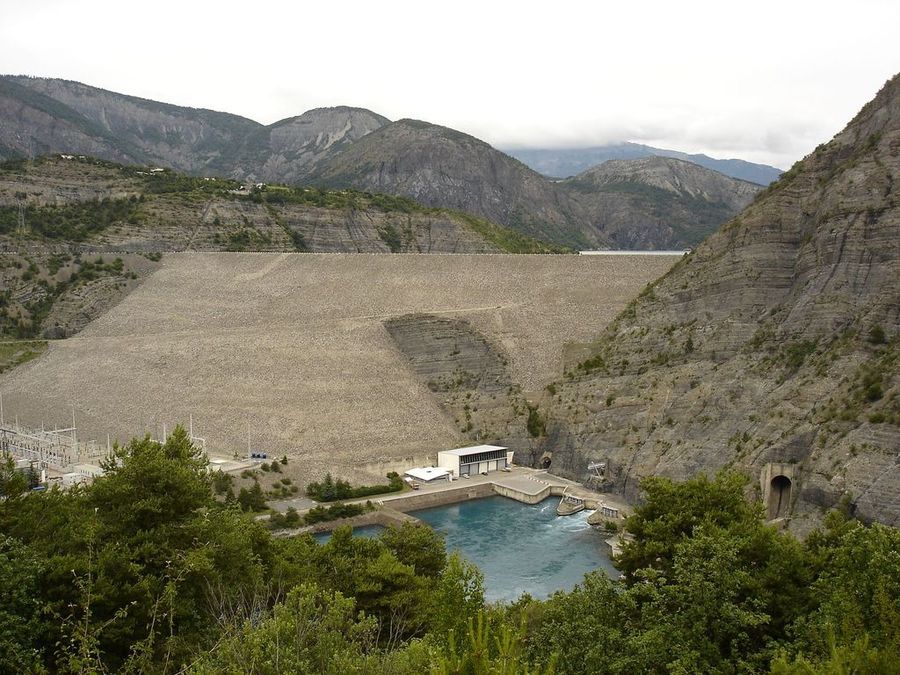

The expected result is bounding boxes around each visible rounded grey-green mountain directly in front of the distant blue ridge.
[560,156,762,249]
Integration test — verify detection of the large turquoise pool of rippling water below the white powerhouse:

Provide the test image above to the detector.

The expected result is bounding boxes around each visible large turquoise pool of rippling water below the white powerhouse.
[412,496,619,601]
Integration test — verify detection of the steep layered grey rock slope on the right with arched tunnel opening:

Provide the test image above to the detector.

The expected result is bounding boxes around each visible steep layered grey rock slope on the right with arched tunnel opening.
[517,76,900,531]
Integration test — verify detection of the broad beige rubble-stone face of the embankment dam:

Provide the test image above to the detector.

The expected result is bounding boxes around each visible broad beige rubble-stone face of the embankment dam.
[0,253,677,482]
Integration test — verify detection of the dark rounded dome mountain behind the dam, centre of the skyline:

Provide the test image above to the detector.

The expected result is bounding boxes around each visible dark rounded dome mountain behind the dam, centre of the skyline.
[310,119,608,248]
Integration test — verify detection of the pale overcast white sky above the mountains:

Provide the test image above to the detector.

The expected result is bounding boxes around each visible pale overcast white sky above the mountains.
[0,0,900,168]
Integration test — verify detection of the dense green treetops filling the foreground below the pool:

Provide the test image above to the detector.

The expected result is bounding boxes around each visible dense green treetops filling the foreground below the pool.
[0,438,900,675]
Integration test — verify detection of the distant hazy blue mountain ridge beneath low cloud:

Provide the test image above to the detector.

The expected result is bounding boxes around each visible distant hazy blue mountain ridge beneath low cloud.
[505,143,782,185]
